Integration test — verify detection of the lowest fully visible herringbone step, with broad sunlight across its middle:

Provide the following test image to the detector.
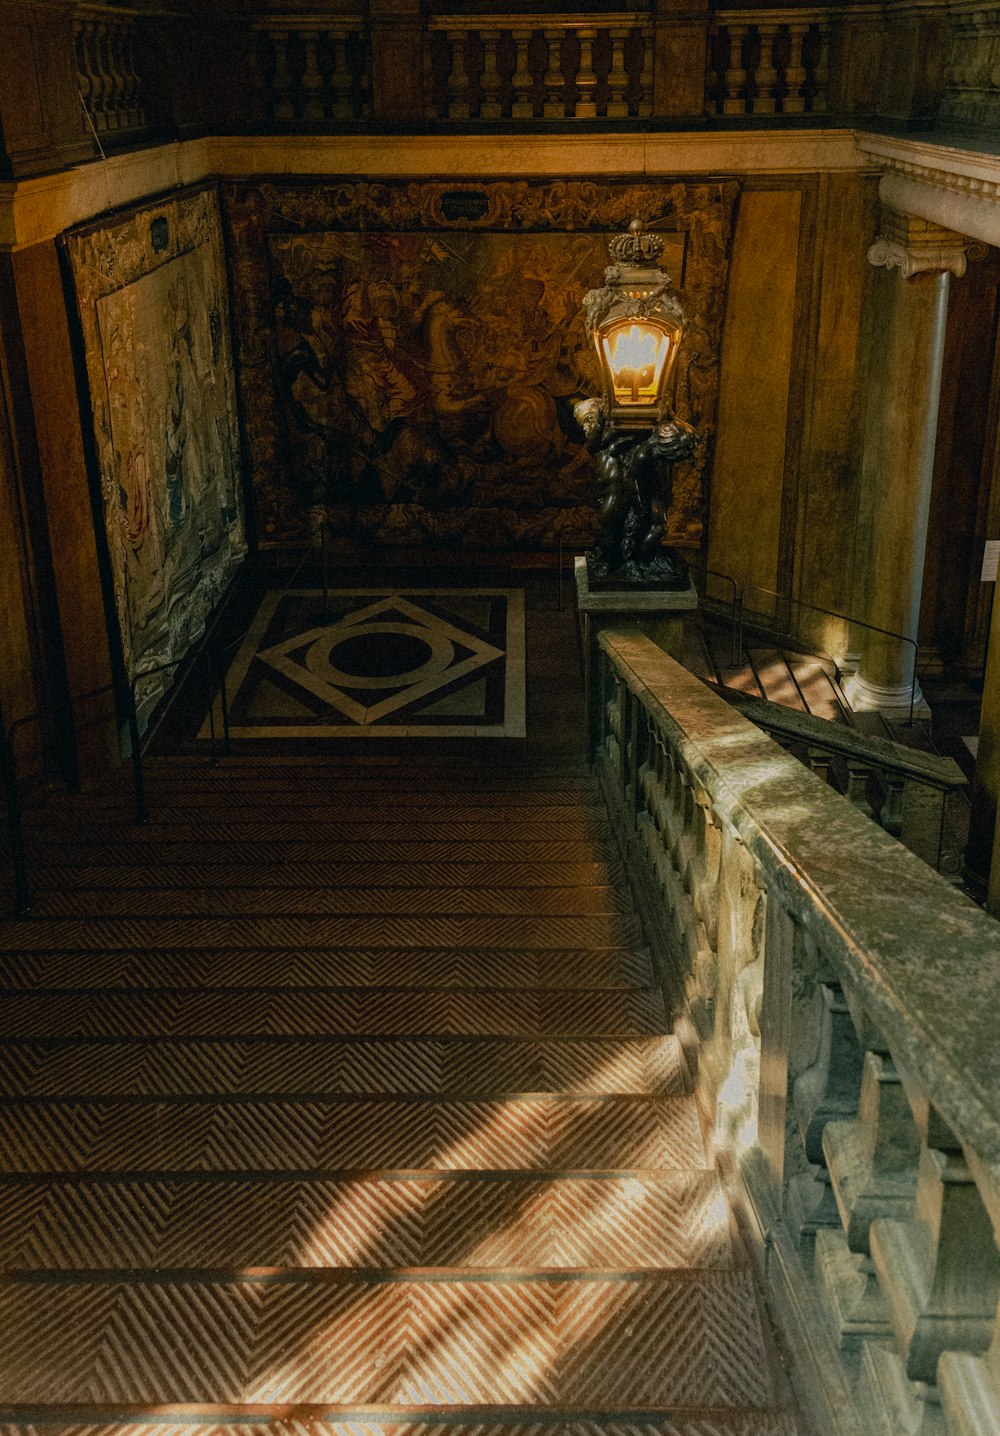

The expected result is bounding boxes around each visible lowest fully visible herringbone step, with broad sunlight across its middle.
[0,1271,776,1420]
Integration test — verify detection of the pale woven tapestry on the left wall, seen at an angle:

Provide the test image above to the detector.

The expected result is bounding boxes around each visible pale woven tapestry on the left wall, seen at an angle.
[66,190,246,717]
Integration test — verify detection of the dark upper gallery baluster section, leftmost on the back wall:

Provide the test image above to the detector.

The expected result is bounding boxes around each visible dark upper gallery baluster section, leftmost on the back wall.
[250,16,372,125]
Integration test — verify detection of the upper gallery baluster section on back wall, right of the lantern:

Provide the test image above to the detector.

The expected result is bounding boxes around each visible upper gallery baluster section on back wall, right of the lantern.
[705,10,830,115]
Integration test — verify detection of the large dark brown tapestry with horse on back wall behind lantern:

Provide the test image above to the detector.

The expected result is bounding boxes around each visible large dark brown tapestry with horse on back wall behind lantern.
[224,181,736,551]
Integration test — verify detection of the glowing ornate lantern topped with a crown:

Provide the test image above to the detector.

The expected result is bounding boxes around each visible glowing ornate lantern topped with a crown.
[583,220,684,429]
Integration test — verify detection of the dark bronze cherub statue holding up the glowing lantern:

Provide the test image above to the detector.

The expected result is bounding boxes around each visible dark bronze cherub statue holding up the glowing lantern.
[573,399,697,589]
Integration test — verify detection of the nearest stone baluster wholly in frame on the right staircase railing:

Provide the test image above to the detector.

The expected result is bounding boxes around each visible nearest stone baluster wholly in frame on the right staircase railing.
[816,1051,920,1348]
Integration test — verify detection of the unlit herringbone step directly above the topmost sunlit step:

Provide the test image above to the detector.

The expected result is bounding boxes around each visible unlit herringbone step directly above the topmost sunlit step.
[0,987,668,1038]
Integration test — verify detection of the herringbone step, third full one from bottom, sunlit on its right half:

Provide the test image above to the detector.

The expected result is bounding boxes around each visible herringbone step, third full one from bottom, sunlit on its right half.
[0,1093,707,1171]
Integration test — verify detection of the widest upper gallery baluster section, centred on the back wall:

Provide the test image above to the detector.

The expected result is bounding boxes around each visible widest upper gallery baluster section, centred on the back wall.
[425,11,652,121]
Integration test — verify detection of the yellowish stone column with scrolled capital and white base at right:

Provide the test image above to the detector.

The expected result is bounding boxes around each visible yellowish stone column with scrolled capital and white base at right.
[846,208,973,711]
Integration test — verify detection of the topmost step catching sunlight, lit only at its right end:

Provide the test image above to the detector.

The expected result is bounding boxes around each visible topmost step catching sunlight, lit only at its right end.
[0,1034,691,1100]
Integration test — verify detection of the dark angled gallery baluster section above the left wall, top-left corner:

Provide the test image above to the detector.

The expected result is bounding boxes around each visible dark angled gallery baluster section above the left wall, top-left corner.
[73,11,147,139]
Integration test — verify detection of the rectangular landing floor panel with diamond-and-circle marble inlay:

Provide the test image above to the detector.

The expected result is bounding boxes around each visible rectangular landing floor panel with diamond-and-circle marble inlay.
[198,587,524,740]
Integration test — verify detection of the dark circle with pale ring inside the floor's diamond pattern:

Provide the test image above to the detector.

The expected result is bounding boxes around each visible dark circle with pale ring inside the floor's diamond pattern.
[306,622,455,688]
